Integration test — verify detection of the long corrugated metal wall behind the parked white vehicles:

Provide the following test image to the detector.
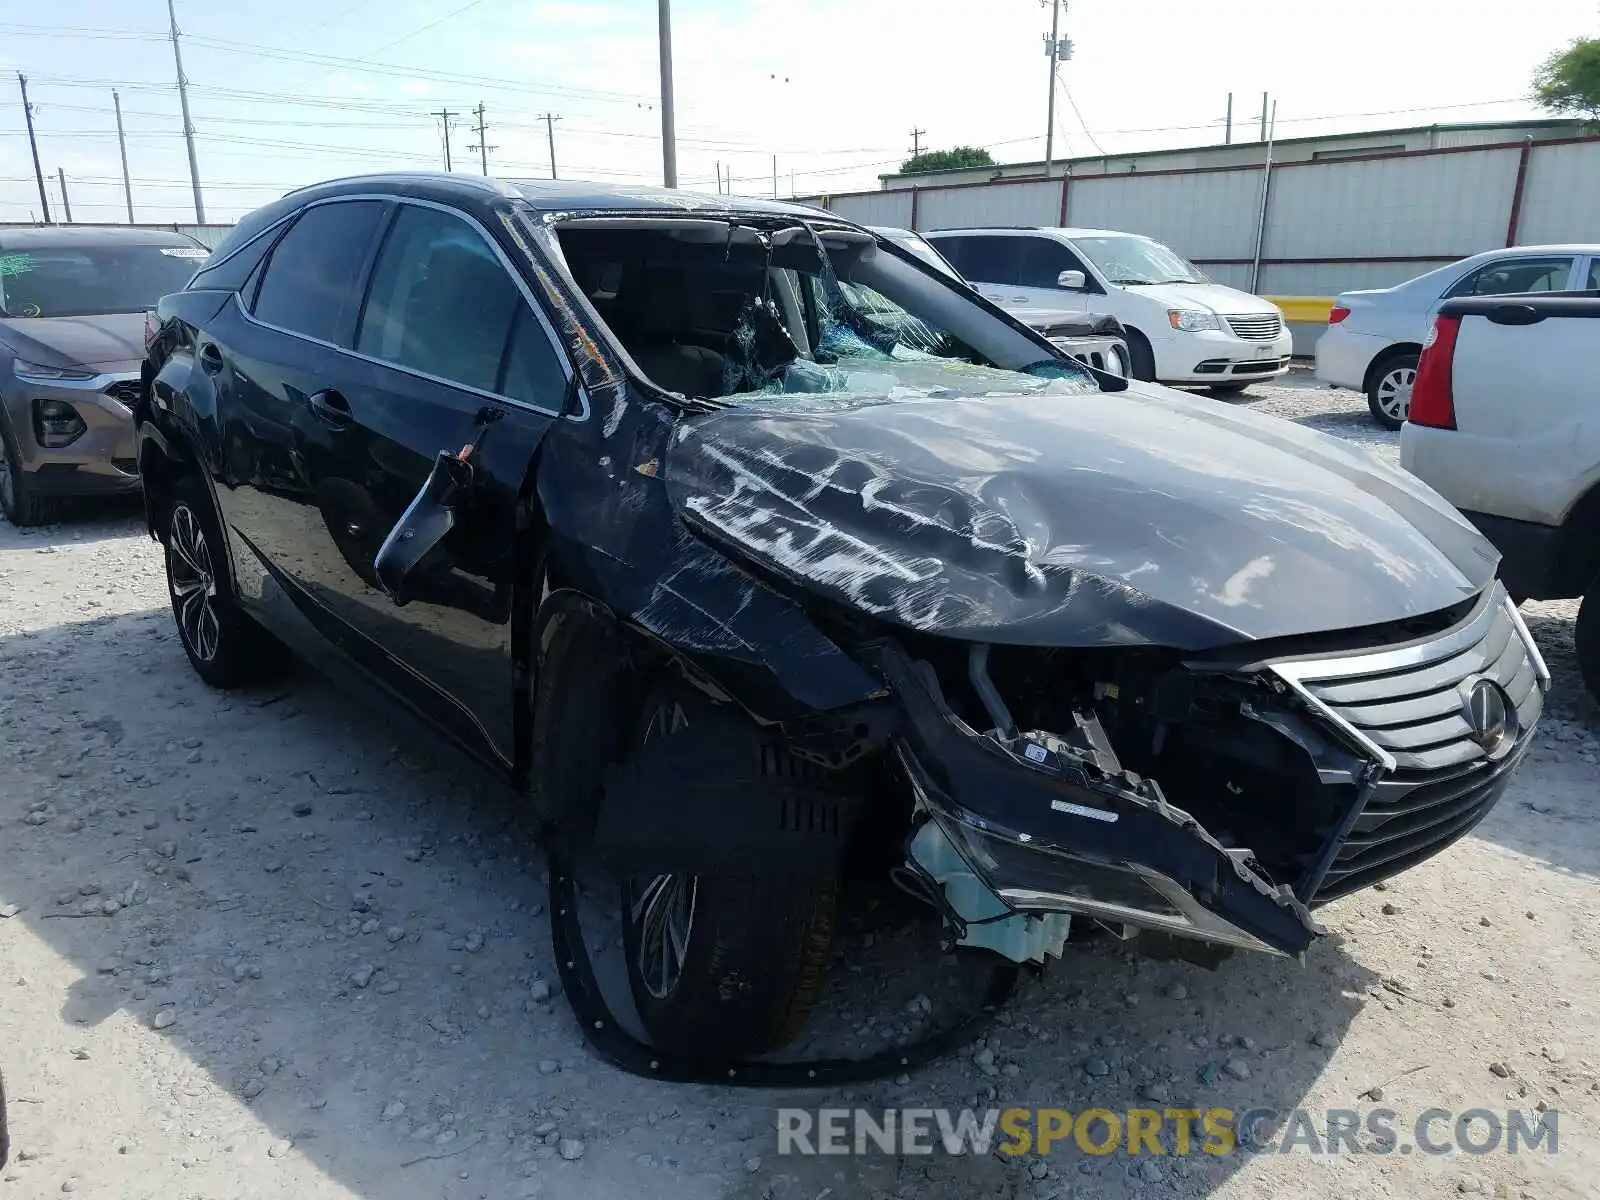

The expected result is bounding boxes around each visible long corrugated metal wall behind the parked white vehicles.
[811,122,1600,352]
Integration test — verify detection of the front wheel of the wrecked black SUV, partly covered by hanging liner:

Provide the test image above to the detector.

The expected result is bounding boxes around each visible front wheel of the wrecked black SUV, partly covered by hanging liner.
[621,672,835,1059]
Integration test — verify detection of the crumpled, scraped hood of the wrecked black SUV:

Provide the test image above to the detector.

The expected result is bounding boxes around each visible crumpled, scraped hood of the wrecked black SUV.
[666,384,1498,650]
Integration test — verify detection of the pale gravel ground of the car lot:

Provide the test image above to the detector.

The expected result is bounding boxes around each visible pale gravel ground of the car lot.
[0,376,1600,1200]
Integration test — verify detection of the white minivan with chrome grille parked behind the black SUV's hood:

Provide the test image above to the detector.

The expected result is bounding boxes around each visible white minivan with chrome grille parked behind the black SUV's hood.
[923,227,1293,392]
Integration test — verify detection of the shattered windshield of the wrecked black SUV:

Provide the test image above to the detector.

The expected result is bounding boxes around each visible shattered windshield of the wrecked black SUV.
[558,218,1099,402]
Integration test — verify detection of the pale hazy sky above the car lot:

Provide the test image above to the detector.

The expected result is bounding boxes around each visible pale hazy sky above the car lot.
[0,0,1600,222]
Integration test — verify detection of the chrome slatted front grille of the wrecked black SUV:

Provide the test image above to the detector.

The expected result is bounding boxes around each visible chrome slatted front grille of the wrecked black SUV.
[1270,584,1549,776]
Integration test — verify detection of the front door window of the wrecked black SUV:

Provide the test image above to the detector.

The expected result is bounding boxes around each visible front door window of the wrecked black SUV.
[355,205,566,400]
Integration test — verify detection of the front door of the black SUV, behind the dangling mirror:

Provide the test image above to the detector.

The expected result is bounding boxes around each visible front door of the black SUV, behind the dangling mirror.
[301,200,570,763]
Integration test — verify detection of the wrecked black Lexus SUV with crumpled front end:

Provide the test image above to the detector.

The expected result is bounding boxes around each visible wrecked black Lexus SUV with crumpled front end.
[138,176,1549,1067]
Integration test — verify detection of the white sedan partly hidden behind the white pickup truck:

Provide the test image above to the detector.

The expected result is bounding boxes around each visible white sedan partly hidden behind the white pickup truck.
[1317,245,1600,429]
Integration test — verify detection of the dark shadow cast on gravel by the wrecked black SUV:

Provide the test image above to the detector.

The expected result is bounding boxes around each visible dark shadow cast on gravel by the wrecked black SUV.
[0,598,1376,1200]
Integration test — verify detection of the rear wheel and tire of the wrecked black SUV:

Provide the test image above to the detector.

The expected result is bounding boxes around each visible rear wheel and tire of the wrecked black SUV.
[162,475,290,688]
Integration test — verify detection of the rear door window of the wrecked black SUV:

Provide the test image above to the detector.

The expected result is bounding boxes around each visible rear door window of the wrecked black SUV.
[253,200,382,346]
